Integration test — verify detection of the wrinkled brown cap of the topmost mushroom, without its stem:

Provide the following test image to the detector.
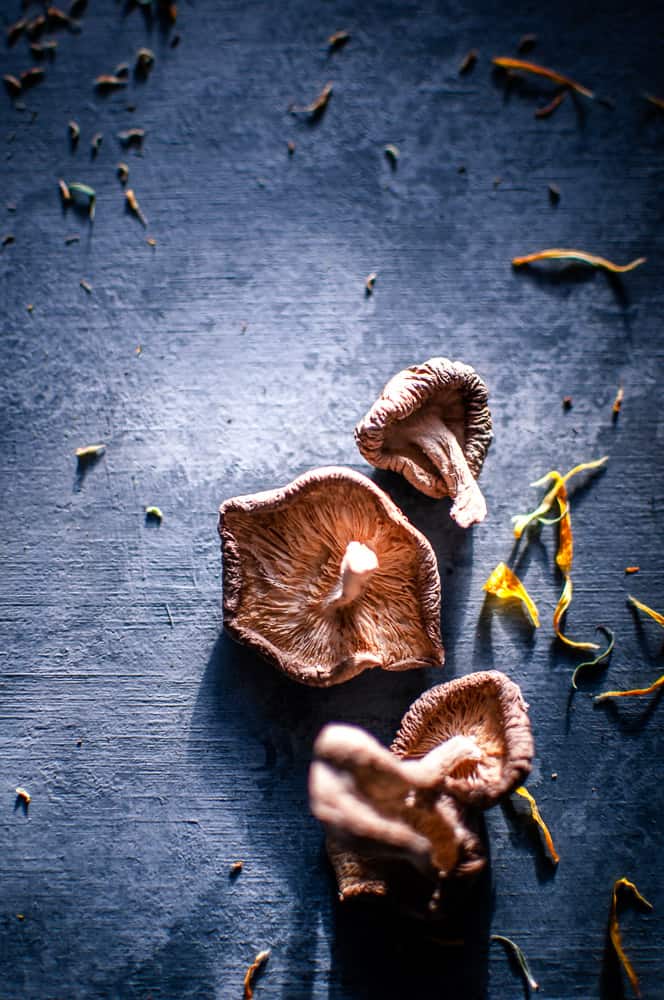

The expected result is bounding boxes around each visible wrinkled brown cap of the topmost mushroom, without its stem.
[355,358,493,497]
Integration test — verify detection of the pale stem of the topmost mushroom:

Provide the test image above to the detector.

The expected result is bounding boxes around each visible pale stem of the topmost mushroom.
[417,419,486,528]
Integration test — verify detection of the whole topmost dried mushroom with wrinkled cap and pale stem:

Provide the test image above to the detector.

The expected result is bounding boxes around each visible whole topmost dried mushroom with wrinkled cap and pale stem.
[355,358,492,528]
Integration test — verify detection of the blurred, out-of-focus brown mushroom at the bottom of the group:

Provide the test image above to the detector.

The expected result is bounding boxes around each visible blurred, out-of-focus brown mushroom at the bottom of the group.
[309,725,484,899]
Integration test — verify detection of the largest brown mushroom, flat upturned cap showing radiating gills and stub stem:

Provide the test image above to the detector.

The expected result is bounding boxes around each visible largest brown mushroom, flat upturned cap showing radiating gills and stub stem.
[219,466,444,687]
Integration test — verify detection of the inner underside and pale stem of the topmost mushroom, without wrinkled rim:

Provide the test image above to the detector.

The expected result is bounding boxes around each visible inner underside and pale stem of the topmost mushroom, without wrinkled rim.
[389,407,486,528]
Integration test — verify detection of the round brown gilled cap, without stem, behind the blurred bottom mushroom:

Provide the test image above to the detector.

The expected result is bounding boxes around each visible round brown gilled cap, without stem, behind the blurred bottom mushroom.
[390,670,534,808]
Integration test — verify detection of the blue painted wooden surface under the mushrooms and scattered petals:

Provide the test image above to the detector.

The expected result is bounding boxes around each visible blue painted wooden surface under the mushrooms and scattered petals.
[0,0,664,1000]
